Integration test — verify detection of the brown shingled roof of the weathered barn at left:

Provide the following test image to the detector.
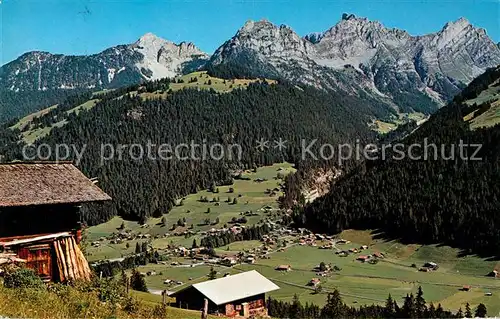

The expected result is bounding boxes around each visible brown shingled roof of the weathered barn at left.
[0,163,111,207]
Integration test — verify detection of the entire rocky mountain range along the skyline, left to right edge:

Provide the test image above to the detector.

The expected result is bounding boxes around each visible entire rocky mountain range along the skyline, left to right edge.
[0,14,500,122]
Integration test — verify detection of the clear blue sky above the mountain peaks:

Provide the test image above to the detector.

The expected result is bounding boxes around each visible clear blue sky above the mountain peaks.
[0,0,500,65]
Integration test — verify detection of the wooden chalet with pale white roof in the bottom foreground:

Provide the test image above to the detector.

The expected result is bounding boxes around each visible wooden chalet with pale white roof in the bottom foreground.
[170,270,279,318]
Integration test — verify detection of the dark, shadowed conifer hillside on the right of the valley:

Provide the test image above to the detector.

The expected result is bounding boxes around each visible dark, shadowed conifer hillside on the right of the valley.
[288,68,500,255]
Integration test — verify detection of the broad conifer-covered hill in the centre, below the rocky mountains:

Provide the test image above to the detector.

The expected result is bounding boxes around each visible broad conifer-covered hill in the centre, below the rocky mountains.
[0,79,380,224]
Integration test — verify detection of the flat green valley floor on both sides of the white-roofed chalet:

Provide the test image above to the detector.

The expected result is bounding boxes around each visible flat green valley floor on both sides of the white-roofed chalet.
[126,231,500,315]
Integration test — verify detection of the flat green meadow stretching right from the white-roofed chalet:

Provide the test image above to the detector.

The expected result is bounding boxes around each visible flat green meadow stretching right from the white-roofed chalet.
[254,232,500,314]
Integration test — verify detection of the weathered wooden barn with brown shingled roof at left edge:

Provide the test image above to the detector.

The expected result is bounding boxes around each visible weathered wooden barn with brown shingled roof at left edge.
[0,162,111,282]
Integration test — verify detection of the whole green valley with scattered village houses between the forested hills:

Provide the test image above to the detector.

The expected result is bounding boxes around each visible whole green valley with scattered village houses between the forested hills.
[78,163,500,314]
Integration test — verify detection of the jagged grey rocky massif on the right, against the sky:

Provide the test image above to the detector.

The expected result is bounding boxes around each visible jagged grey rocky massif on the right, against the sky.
[209,15,500,111]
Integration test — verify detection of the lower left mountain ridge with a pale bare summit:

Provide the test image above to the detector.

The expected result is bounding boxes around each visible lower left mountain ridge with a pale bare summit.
[0,33,208,92]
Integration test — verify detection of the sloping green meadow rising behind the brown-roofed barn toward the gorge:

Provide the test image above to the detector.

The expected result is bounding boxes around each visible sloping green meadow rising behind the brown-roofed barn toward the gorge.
[86,163,294,261]
